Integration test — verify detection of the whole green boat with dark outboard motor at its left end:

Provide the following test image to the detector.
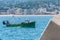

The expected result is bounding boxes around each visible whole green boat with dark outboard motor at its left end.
[3,20,35,28]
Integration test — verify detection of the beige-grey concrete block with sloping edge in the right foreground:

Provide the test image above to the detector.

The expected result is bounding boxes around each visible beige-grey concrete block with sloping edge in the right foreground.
[40,14,60,40]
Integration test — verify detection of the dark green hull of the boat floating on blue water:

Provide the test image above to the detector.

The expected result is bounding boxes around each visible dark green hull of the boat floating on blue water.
[6,22,35,28]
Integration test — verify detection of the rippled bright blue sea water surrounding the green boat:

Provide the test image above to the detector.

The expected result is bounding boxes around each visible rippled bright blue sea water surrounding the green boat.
[0,16,53,40]
